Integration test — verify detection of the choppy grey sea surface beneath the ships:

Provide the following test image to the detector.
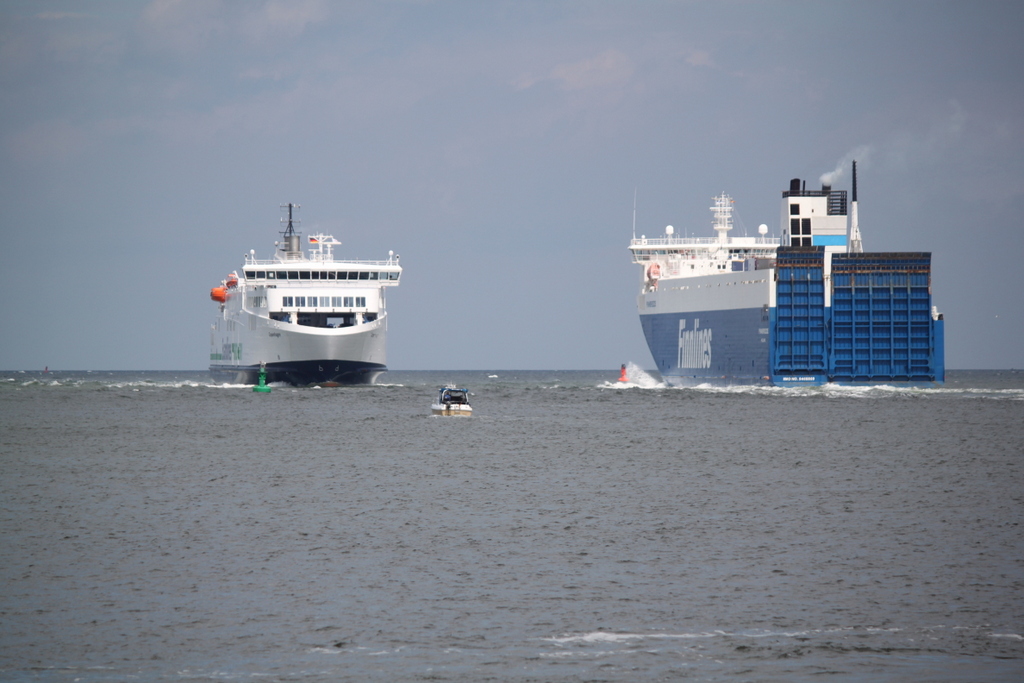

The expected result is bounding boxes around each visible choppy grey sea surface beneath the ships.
[0,371,1024,683]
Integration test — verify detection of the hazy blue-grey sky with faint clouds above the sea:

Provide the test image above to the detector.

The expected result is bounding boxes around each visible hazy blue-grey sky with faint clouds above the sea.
[0,0,1024,372]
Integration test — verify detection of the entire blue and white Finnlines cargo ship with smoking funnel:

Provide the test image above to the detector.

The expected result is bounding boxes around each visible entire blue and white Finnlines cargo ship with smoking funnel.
[630,162,945,386]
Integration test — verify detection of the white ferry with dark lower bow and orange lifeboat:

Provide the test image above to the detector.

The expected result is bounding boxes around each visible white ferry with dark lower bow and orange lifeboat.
[210,204,401,386]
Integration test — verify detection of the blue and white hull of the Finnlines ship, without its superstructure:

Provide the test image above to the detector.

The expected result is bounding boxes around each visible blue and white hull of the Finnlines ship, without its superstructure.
[637,249,945,387]
